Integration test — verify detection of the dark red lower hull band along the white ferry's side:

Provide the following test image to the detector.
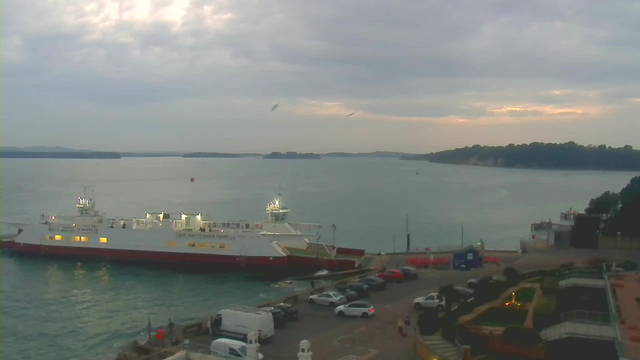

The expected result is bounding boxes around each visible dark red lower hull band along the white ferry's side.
[13,243,287,266]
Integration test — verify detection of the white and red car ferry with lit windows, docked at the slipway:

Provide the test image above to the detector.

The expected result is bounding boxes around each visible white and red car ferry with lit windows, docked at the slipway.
[3,191,364,270]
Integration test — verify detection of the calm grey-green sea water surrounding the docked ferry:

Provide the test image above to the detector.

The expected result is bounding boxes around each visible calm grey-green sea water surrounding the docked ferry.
[0,158,636,360]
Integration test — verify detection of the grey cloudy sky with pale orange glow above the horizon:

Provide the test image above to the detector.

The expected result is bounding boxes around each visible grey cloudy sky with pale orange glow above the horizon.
[0,0,640,152]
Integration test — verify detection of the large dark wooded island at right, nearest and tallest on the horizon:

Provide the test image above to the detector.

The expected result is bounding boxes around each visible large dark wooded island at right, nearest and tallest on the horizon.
[401,141,640,171]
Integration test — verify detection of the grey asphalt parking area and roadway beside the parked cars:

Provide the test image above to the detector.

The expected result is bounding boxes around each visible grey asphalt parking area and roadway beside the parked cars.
[252,266,501,360]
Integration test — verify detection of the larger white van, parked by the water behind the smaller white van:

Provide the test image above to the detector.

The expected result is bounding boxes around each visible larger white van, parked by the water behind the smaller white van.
[207,306,275,342]
